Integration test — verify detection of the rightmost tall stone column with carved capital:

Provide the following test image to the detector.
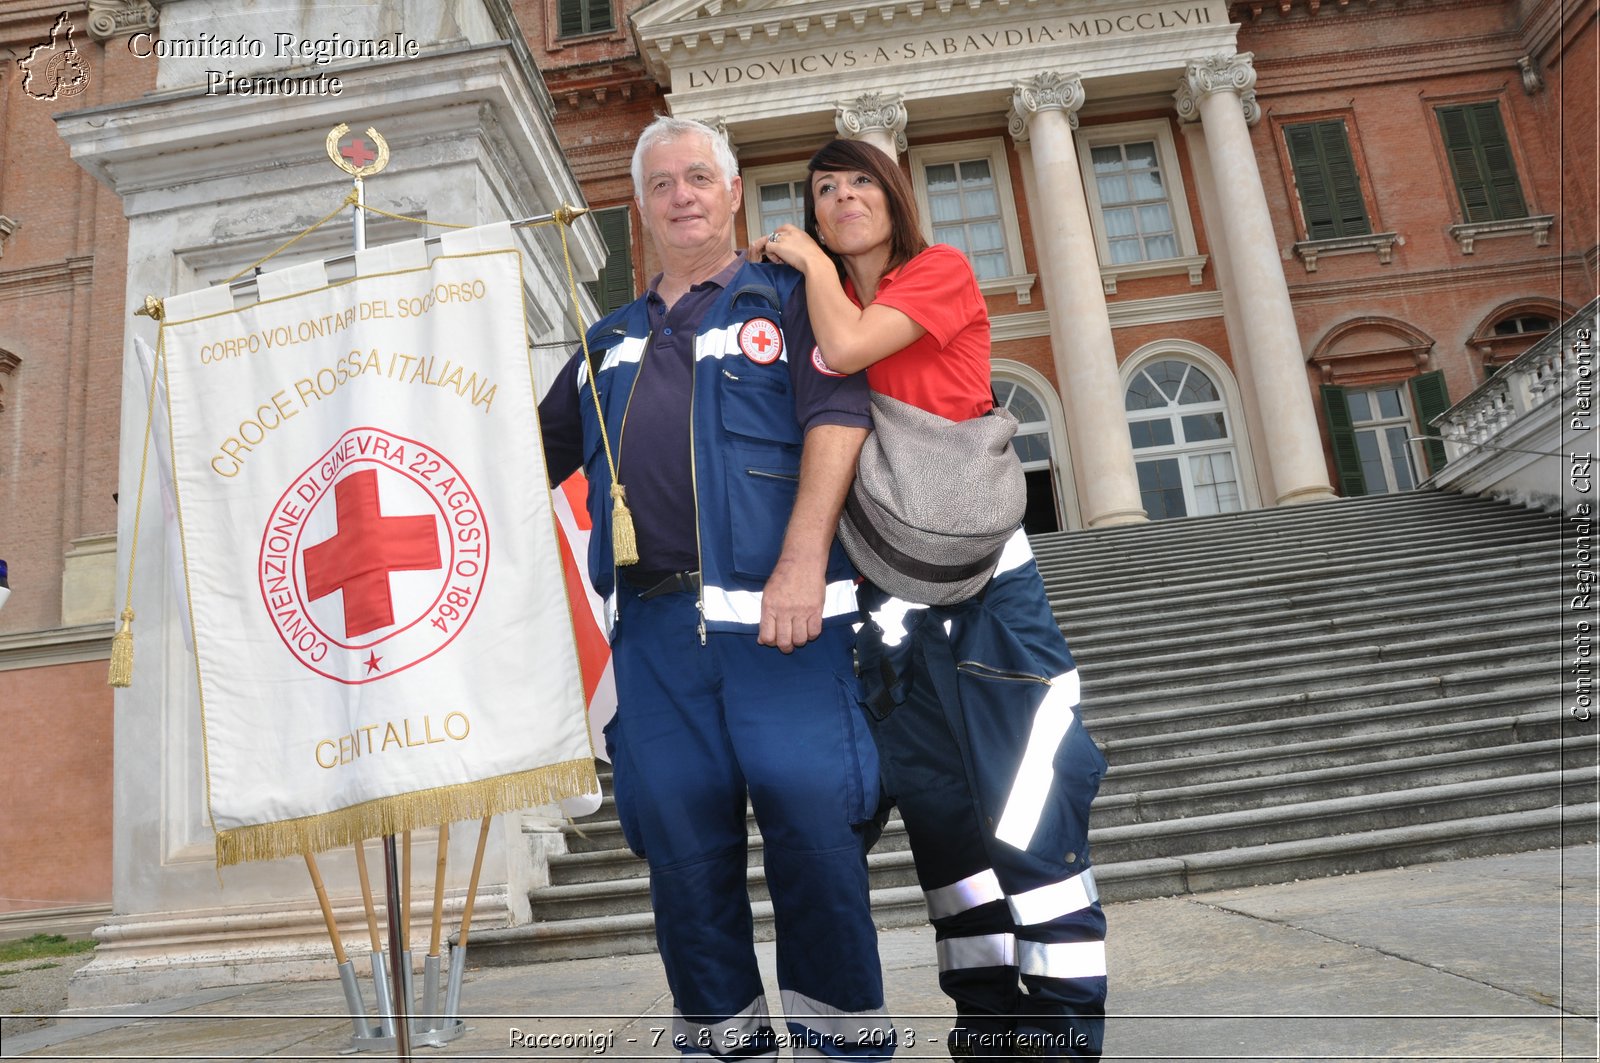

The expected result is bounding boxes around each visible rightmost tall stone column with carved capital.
[1173,53,1333,506]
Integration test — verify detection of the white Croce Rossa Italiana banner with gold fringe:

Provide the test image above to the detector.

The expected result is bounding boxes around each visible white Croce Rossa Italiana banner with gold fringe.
[160,227,598,864]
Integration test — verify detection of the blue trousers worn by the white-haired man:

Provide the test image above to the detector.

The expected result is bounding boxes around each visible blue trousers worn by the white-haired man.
[606,586,893,1060]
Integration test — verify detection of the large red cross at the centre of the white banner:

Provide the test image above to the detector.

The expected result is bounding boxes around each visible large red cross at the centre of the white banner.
[304,469,442,639]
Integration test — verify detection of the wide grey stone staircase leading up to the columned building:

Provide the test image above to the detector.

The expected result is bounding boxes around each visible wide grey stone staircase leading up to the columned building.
[472,491,1597,964]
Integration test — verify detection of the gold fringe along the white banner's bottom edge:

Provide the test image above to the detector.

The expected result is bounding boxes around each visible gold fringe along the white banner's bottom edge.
[216,757,600,868]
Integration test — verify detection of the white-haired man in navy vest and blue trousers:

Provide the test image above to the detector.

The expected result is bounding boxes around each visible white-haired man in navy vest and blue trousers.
[539,118,893,1058]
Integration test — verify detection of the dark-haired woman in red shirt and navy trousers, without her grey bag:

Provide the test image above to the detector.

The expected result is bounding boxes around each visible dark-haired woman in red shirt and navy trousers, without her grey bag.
[750,141,1106,1060]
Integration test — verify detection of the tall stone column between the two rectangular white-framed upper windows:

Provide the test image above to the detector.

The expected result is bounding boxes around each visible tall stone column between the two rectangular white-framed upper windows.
[1008,72,1146,528]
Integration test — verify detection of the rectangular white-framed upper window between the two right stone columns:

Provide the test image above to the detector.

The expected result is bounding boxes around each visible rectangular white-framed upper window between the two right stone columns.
[1077,120,1205,291]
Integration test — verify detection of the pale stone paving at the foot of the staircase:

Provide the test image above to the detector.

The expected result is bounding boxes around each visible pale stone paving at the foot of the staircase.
[0,845,1600,1063]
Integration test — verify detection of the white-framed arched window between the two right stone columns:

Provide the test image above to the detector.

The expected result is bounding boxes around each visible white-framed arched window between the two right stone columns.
[1123,359,1245,520]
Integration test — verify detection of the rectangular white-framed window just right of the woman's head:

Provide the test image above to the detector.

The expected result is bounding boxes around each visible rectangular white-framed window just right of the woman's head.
[909,139,1034,303]
